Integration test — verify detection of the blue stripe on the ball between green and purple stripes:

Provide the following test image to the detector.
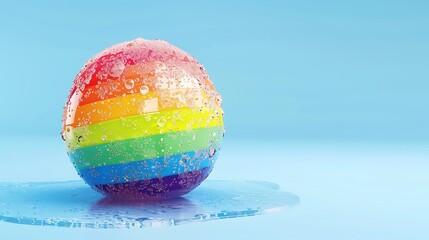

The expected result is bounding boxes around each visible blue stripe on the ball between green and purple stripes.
[78,149,219,186]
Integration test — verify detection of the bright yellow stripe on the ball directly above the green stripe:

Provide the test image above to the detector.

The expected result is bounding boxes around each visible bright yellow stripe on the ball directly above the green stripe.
[65,106,223,151]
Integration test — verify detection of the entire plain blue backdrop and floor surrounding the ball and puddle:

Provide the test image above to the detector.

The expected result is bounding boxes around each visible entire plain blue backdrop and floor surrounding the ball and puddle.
[0,0,429,240]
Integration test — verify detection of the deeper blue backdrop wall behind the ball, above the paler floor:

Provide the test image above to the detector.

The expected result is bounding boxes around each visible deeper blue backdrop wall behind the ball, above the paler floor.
[0,0,429,141]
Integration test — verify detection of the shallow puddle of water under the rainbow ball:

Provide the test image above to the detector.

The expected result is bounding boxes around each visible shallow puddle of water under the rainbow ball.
[0,180,299,228]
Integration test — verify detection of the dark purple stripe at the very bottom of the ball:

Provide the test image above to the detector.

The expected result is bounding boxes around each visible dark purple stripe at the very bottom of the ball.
[93,167,213,201]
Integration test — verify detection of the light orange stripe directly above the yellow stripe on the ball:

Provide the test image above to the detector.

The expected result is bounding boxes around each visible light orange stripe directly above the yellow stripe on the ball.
[67,88,209,127]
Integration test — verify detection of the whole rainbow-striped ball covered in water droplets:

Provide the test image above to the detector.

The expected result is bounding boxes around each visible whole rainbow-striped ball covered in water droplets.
[62,39,224,200]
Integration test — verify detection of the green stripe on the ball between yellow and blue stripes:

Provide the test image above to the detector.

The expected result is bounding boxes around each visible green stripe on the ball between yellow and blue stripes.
[70,126,223,169]
